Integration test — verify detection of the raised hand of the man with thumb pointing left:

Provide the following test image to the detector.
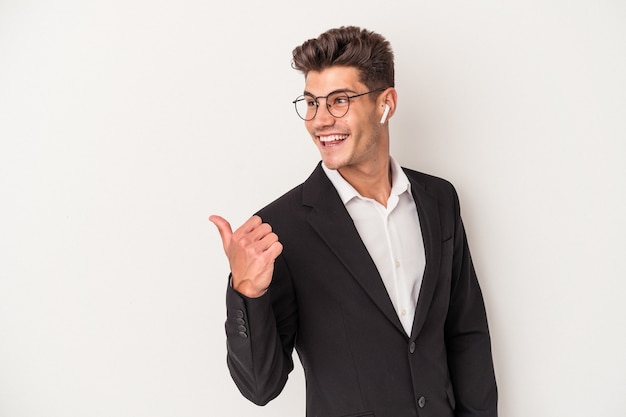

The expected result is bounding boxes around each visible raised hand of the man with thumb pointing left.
[209,216,283,298]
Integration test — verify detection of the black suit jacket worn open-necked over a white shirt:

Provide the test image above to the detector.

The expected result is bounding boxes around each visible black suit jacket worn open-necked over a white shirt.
[226,165,497,417]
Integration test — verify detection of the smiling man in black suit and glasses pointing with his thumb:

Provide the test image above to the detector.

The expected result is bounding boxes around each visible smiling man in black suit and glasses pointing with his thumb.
[210,27,497,417]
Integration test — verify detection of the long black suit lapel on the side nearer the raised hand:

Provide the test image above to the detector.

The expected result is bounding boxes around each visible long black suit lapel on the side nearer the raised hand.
[303,164,404,333]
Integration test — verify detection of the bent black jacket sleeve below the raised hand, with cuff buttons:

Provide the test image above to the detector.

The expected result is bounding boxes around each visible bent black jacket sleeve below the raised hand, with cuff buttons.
[225,252,297,405]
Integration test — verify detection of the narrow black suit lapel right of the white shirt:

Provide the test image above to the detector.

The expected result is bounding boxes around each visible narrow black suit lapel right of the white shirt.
[405,171,441,340]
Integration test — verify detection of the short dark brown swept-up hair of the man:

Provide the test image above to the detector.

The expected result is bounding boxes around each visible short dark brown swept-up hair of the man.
[291,26,395,89]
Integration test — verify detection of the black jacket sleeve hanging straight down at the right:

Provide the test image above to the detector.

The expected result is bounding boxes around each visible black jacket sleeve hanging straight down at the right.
[445,186,498,417]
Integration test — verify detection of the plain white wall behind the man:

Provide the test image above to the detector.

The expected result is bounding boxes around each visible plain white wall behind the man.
[0,0,626,417]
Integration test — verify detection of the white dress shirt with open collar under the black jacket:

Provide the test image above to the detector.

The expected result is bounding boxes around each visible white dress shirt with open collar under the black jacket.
[322,158,426,335]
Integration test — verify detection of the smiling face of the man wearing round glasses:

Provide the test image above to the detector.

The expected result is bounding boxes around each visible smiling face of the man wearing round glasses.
[305,67,389,172]
